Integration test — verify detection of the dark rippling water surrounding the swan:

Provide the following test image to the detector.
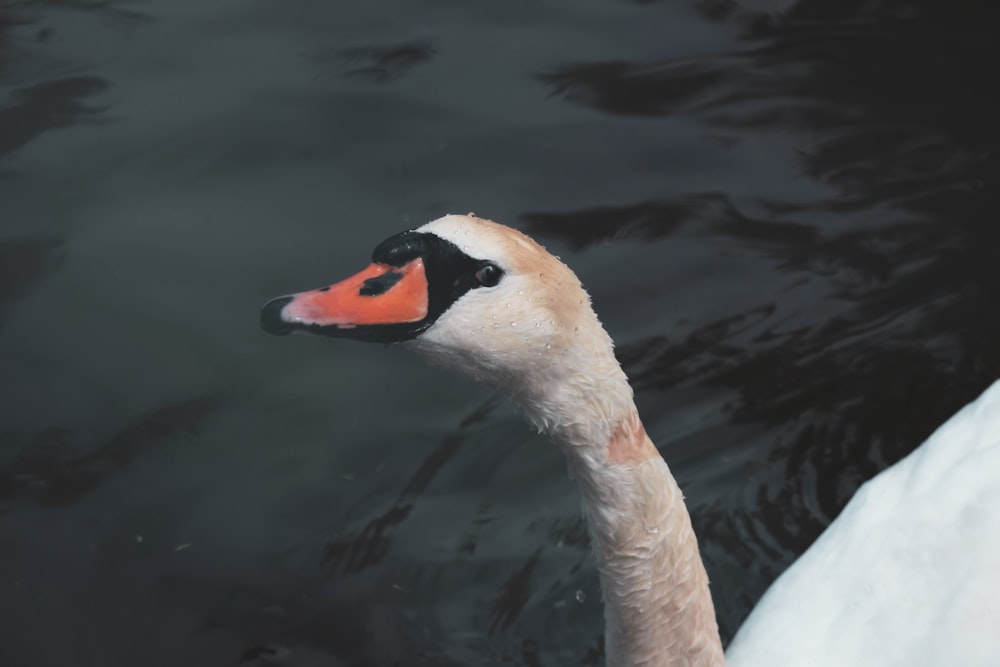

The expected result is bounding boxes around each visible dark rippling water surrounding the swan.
[0,0,1000,667]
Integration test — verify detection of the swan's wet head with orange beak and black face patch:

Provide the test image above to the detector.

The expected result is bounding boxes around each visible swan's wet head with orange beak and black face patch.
[261,215,631,438]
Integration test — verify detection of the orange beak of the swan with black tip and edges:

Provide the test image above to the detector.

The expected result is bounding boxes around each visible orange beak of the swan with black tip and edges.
[261,257,429,339]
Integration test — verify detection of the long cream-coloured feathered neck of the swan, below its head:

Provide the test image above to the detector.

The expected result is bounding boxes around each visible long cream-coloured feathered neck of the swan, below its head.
[552,392,724,667]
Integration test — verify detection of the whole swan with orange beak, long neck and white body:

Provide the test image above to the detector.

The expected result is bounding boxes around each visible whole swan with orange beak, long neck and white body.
[261,214,1000,667]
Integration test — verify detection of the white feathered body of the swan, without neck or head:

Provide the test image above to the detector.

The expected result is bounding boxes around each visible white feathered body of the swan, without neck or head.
[726,382,1000,667]
